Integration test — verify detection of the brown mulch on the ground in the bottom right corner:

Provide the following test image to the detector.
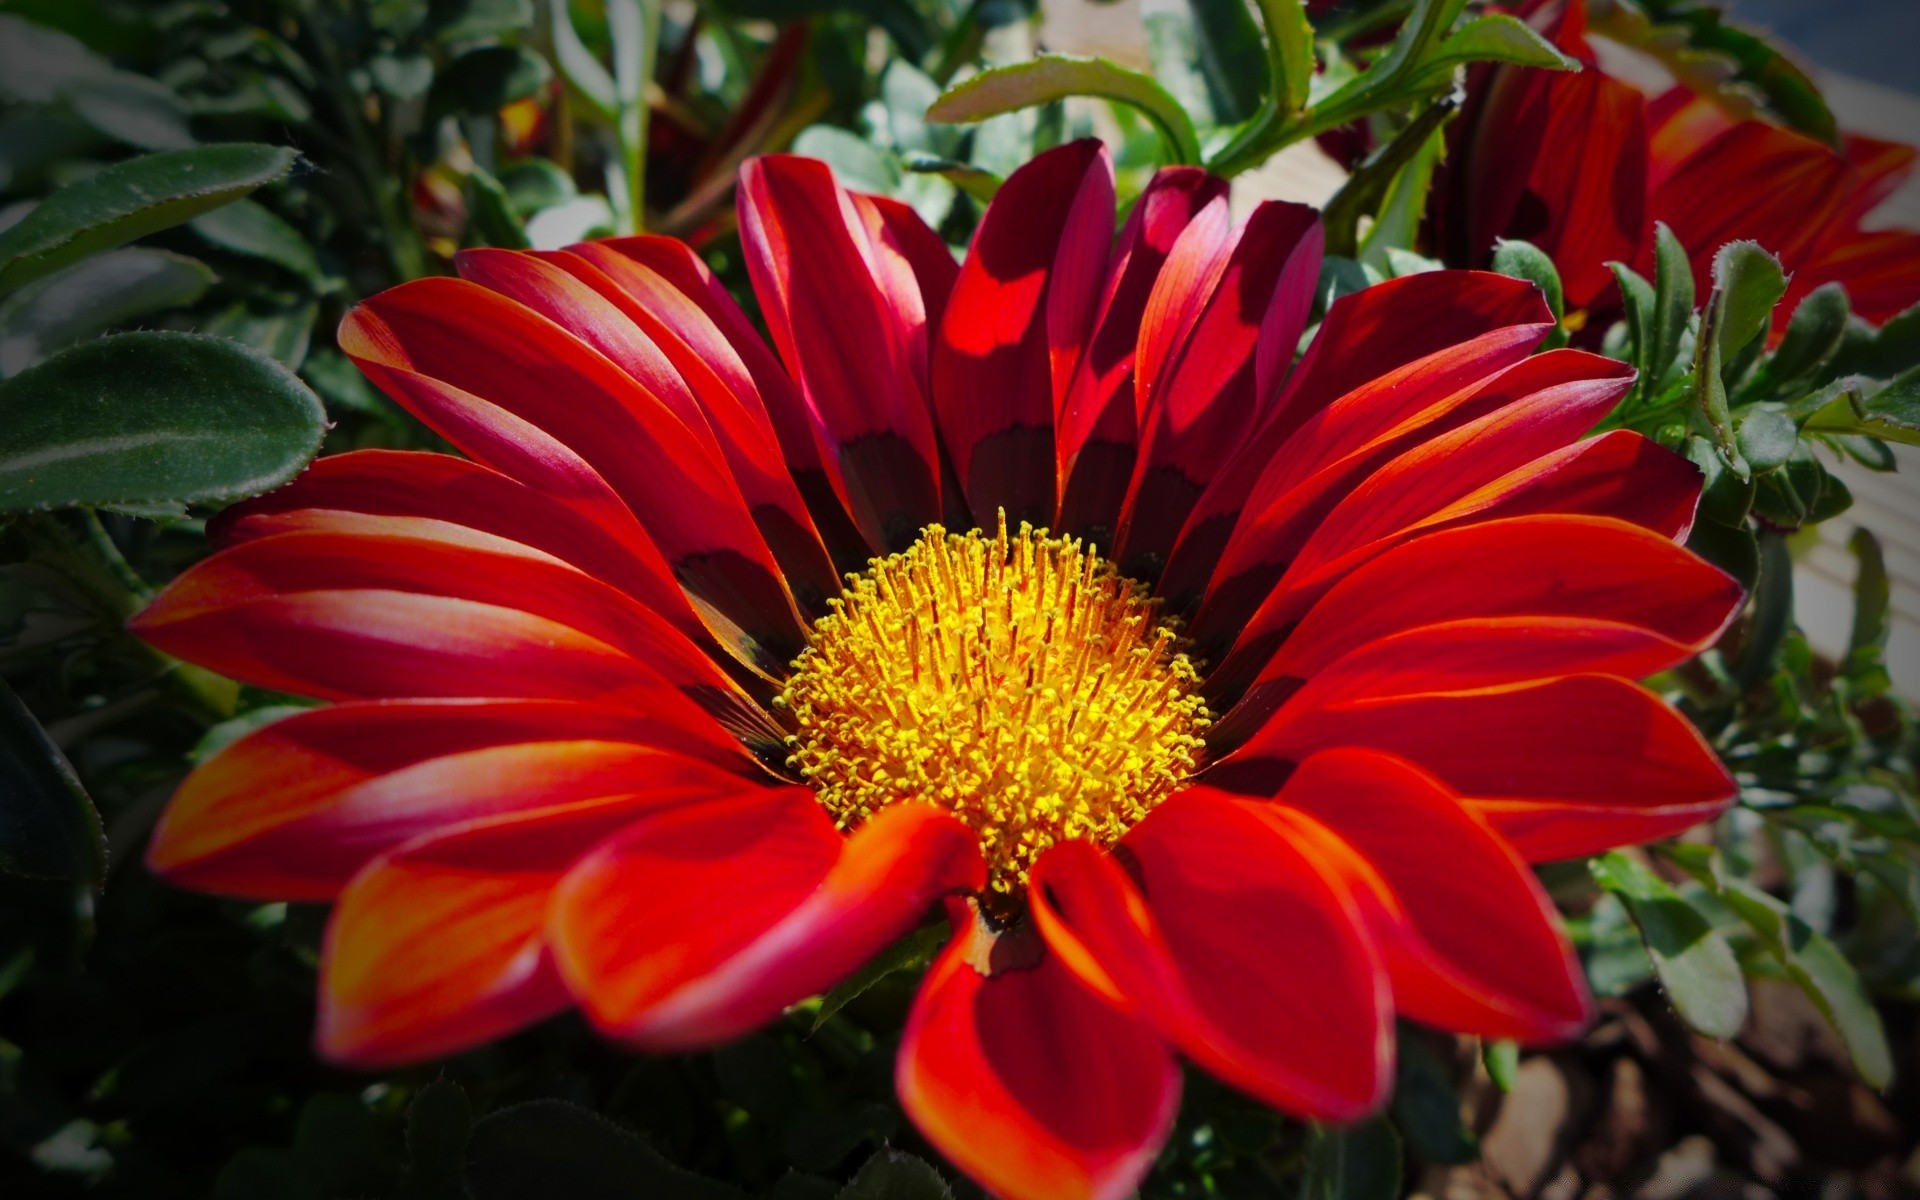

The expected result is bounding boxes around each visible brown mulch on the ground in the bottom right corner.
[1415,981,1920,1200]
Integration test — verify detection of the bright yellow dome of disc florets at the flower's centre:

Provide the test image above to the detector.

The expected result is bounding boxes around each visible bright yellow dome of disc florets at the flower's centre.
[780,518,1208,893]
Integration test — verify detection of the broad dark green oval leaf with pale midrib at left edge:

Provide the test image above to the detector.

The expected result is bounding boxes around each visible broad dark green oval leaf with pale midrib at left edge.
[0,332,326,511]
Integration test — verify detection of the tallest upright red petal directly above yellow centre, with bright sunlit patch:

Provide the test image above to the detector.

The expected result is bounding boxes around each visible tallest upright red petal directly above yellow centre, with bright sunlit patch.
[933,140,1114,526]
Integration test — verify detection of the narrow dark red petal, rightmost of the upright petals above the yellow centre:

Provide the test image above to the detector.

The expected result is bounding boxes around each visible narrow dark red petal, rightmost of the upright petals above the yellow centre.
[1116,202,1323,559]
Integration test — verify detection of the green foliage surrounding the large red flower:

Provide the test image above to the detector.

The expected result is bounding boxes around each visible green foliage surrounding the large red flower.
[0,0,1920,1200]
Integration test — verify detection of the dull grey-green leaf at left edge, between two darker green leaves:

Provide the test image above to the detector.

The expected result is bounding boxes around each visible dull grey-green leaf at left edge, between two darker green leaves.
[0,248,213,378]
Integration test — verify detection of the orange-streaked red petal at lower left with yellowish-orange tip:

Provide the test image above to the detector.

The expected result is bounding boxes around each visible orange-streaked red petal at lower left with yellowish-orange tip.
[315,801,632,1068]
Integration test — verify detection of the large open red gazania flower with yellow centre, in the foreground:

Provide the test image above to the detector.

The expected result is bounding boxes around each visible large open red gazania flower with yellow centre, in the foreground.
[136,142,1740,1200]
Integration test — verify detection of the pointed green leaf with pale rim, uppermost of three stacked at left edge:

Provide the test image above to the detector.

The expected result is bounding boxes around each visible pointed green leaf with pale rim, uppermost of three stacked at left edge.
[0,142,296,296]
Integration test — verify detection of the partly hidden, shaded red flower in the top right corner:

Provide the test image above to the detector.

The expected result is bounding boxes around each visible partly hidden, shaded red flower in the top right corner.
[1432,0,1920,324]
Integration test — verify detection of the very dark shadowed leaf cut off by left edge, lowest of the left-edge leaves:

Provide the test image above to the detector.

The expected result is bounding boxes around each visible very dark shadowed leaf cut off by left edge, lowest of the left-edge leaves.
[0,680,108,887]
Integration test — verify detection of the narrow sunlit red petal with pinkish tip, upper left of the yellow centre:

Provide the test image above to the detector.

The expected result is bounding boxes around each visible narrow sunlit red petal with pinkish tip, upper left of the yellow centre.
[459,250,839,612]
